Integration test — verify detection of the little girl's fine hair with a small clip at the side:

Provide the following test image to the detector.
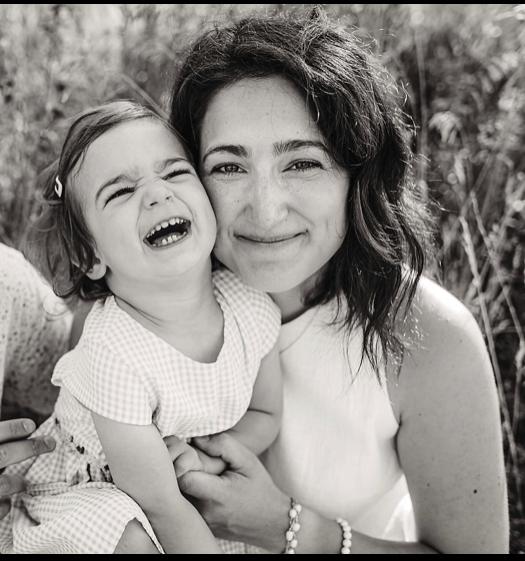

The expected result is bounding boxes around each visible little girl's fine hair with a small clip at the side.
[27,101,171,300]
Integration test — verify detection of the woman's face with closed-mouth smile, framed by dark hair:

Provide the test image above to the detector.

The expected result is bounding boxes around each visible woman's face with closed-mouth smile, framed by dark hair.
[200,76,349,300]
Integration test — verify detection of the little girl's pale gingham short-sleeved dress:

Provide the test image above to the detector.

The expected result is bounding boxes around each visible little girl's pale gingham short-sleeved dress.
[0,270,280,553]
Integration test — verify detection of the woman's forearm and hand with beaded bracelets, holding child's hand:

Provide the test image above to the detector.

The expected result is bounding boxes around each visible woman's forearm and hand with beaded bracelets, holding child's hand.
[179,433,435,553]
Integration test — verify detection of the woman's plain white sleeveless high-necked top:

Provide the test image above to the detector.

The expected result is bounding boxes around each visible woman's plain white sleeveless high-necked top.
[263,304,416,541]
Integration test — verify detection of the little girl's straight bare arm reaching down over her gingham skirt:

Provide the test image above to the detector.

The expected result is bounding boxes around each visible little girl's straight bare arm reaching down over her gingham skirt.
[92,412,221,553]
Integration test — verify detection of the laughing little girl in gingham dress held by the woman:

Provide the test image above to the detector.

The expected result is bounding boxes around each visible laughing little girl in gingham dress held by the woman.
[1,102,281,553]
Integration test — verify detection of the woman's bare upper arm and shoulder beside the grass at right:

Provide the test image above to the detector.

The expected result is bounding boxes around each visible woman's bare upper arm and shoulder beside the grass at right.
[388,279,509,553]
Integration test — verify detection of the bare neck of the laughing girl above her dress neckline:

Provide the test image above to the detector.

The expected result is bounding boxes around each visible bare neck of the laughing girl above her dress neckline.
[115,260,223,362]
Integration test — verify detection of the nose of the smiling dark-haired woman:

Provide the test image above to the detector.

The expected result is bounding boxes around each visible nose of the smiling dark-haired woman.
[249,175,288,229]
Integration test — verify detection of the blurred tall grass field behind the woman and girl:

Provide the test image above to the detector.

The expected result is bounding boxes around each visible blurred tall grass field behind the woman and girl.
[0,4,525,553]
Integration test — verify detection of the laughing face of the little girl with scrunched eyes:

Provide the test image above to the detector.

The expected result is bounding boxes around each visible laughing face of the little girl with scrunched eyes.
[72,118,216,295]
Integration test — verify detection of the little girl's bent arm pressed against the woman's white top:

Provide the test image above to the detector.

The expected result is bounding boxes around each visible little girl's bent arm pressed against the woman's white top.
[226,345,283,455]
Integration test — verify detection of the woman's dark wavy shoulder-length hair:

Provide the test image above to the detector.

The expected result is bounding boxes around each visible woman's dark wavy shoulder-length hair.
[170,9,430,366]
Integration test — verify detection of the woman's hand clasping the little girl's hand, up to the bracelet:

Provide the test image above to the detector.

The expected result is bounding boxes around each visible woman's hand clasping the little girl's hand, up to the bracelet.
[179,434,290,551]
